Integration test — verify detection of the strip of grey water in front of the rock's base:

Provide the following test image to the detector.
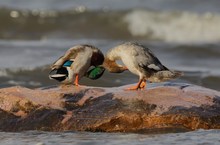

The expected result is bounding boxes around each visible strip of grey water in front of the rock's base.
[0,130,220,145]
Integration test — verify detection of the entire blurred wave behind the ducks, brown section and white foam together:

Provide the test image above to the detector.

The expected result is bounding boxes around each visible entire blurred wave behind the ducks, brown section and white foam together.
[0,6,220,43]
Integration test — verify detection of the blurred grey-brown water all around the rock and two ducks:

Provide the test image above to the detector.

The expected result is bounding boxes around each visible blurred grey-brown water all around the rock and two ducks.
[0,0,220,145]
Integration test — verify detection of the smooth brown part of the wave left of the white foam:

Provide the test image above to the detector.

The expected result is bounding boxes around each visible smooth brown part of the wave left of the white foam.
[0,7,131,39]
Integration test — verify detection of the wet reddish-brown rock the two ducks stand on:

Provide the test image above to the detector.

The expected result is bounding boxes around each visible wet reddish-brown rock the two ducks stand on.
[0,83,220,133]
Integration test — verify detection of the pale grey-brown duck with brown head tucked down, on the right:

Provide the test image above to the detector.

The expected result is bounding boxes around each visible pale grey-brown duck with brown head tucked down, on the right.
[103,42,183,90]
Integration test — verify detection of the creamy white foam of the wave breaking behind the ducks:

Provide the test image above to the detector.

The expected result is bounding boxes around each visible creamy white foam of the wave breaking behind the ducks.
[124,10,220,43]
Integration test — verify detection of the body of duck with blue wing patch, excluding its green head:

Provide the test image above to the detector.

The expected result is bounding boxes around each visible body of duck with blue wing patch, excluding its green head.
[49,44,104,86]
